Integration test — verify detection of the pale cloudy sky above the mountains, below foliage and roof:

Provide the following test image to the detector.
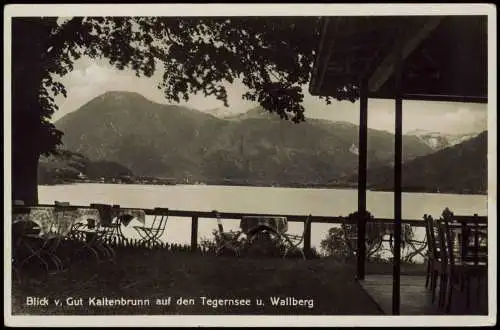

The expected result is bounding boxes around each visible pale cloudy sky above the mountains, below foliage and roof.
[52,57,488,134]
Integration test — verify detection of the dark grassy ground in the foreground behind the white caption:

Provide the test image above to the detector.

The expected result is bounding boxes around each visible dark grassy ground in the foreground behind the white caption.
[7,249,423,315]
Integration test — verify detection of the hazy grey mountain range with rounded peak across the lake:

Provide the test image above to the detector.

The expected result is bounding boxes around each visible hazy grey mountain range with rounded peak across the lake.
[41,92,486,193]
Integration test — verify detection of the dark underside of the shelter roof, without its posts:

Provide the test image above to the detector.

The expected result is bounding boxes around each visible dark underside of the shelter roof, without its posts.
[310,16,488,103]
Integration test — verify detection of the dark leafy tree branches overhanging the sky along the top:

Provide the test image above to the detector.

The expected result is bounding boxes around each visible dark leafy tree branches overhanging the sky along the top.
[12,17,348,157]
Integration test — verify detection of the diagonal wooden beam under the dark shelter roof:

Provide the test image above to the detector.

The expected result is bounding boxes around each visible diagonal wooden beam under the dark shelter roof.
[368,17,441,93]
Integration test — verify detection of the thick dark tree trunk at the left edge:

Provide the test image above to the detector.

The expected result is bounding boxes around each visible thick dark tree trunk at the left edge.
[11,18,49,205]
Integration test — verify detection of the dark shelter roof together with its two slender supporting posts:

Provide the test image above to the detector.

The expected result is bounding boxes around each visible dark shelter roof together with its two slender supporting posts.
[309,16,488,314]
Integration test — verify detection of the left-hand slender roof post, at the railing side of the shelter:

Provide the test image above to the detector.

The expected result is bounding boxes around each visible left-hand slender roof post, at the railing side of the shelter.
[356,80,368,280]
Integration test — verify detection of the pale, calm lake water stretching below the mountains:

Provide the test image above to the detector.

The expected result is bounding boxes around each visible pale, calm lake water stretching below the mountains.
[38,183,487,256]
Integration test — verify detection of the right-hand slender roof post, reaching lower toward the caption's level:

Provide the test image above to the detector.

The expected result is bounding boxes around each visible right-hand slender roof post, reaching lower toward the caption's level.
[392,47,403,315]
